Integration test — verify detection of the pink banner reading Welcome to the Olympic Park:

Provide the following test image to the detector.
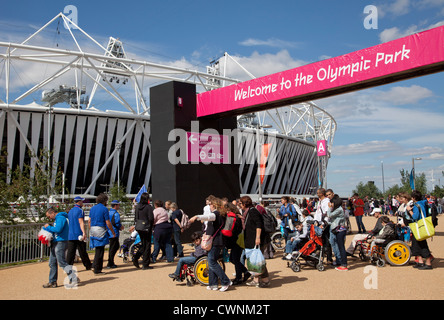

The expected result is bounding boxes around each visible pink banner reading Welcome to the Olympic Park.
[197,26,444,117]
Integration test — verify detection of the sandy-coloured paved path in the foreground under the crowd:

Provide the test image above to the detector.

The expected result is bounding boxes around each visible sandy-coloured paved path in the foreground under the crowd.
[0,215,444,300]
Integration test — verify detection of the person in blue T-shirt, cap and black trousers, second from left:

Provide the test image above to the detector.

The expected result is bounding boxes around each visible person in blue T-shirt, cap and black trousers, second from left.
[66,196,92,270]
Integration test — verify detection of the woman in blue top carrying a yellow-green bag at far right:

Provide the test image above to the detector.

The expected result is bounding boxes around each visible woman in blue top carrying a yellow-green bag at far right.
[407,190,433,270]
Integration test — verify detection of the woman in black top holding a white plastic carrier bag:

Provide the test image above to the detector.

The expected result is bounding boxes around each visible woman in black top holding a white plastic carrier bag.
[240,196,270,288]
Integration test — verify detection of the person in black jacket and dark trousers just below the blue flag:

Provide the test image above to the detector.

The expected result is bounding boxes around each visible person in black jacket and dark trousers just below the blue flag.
[130,192,154,270]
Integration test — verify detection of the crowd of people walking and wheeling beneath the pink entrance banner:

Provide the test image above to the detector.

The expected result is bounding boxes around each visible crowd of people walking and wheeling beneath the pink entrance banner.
[43,188,439,292]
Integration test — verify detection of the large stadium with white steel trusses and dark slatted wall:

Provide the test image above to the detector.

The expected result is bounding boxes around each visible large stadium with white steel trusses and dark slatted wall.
[0,13,336,196]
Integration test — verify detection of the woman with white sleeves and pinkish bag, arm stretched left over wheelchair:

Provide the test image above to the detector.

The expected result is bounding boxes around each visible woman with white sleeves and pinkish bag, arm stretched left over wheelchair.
[189,198,232,292]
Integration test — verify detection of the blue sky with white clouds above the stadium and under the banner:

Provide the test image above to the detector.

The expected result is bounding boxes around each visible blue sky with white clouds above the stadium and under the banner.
[0,0,444,196]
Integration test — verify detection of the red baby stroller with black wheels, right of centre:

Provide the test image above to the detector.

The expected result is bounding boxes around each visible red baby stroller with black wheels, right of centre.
[287,224,325,272]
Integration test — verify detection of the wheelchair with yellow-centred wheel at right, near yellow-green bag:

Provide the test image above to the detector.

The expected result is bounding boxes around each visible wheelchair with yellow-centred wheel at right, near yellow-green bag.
[356,235,411,267]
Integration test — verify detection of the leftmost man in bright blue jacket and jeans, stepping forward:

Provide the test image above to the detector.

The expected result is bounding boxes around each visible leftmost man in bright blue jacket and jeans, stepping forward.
[43,207,78,288]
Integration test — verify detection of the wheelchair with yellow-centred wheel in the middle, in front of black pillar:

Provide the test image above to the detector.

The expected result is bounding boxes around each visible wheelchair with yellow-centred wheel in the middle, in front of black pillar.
[173,256,225,287]
